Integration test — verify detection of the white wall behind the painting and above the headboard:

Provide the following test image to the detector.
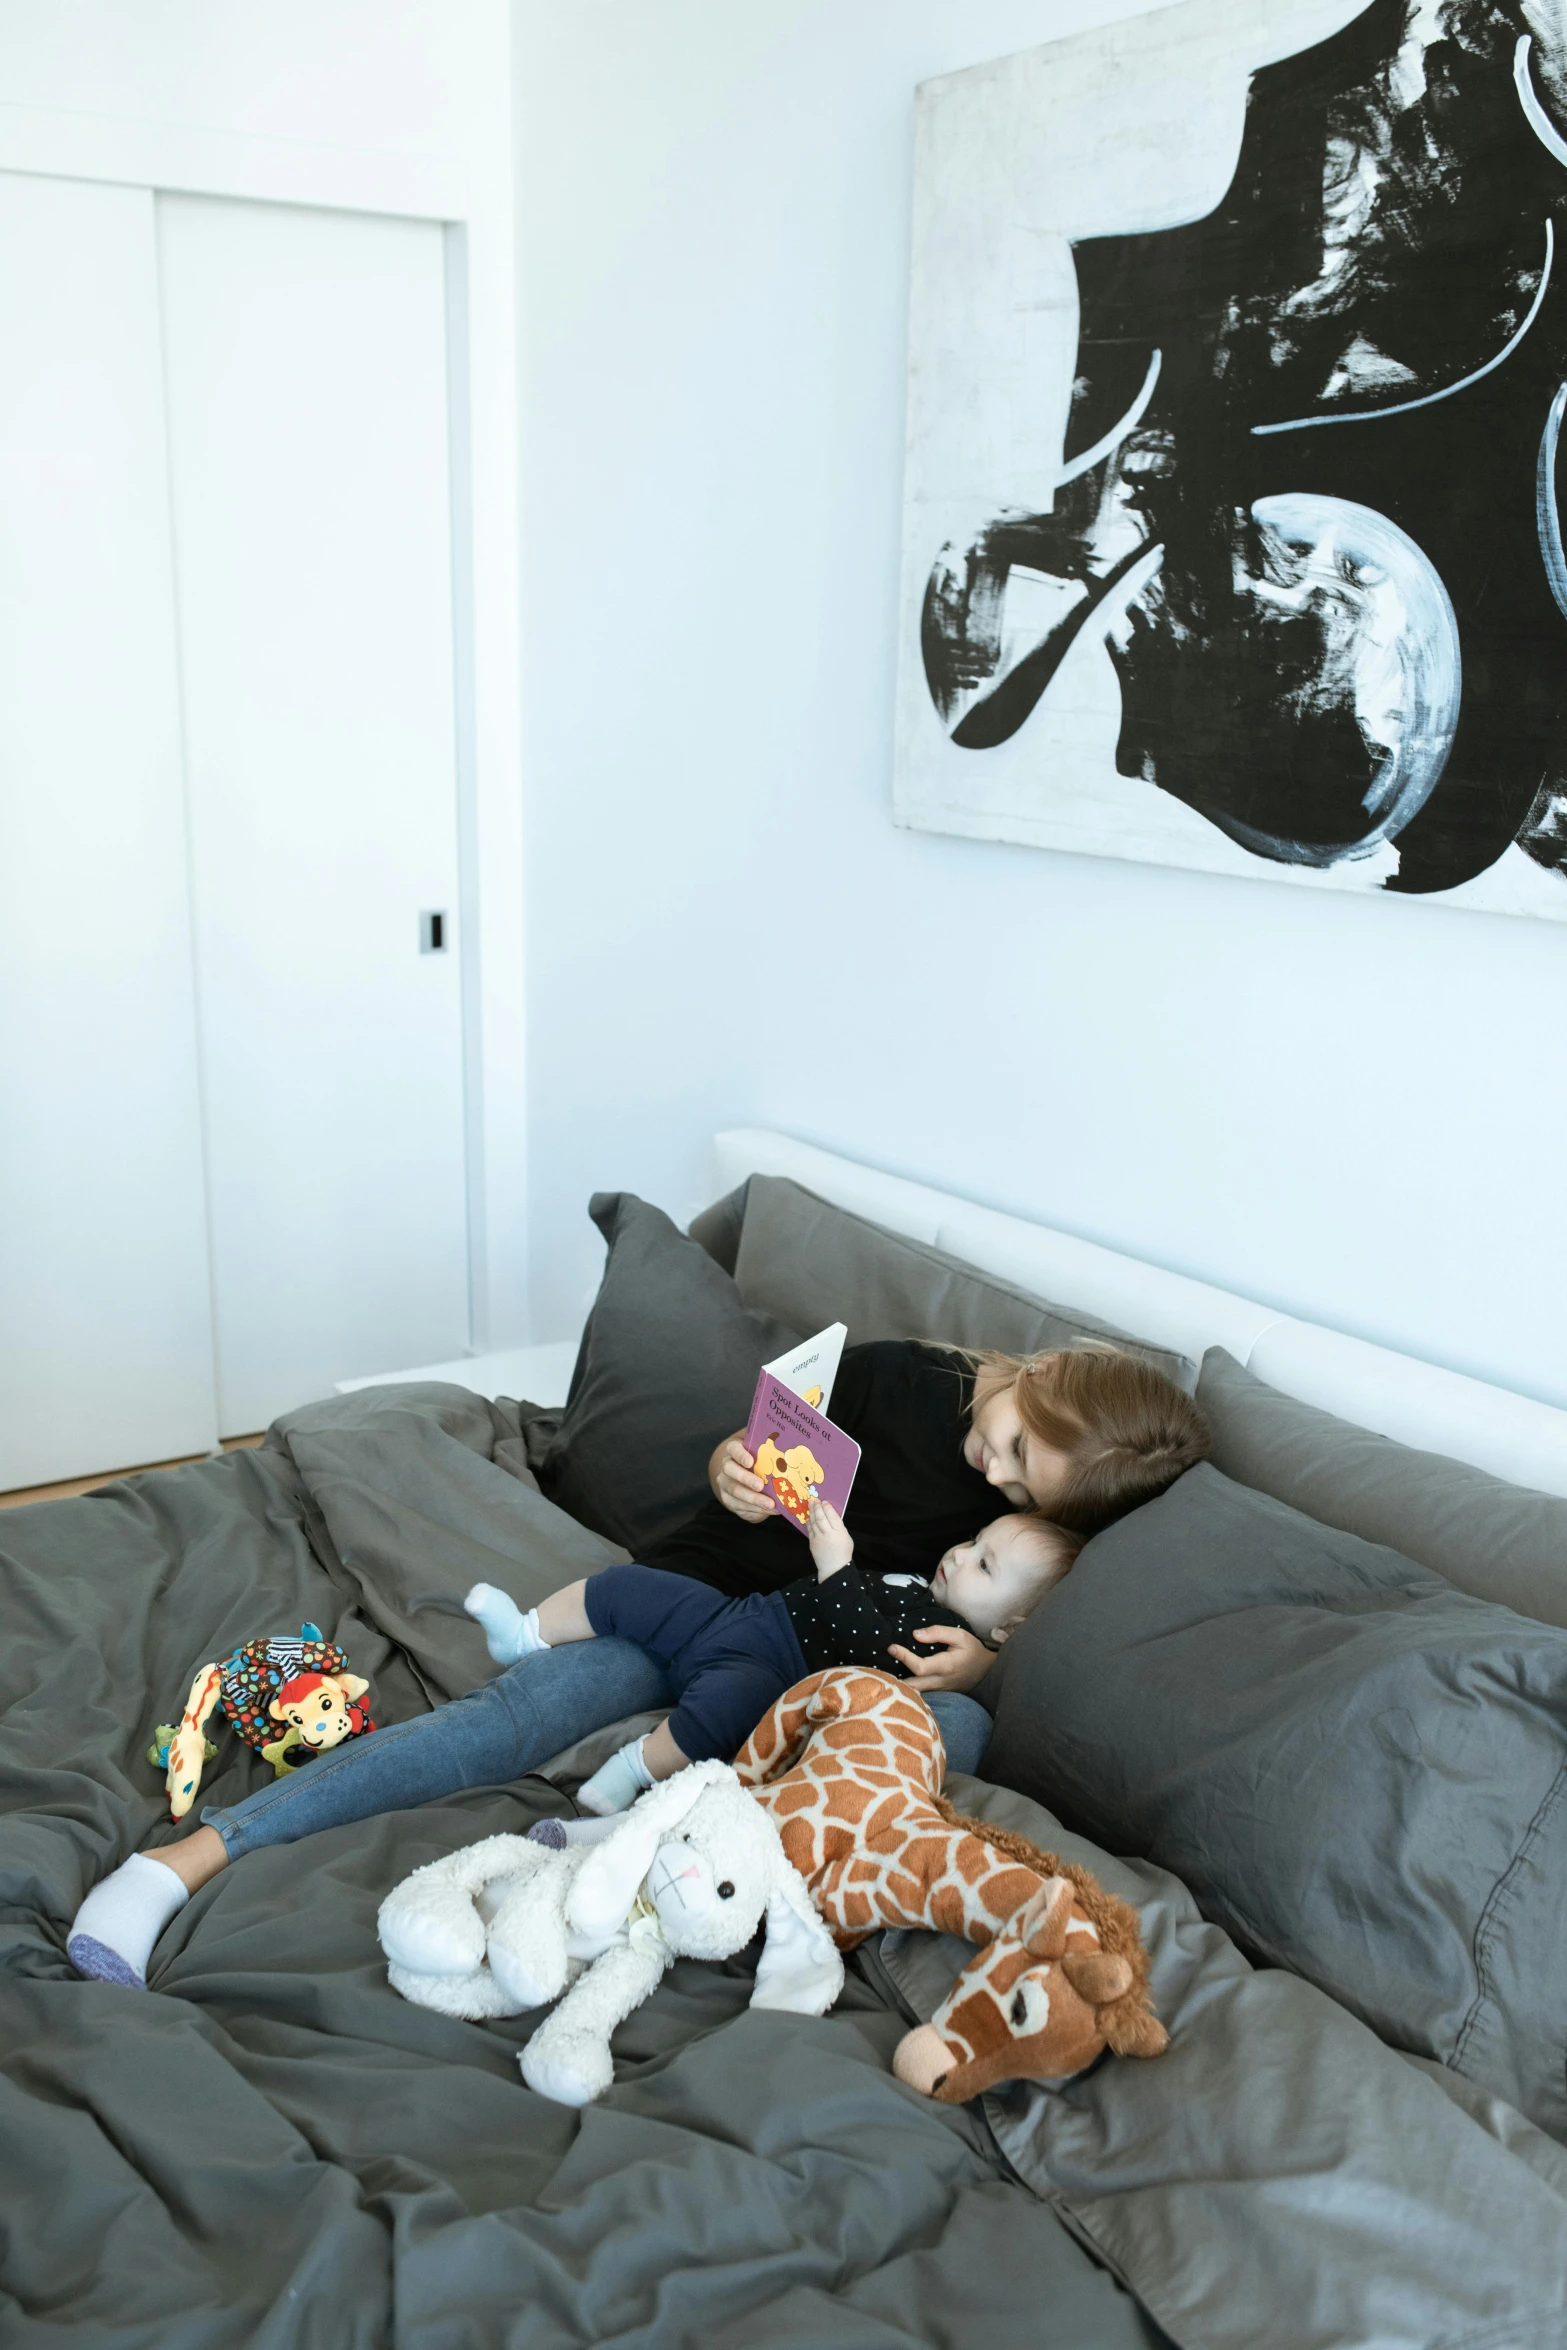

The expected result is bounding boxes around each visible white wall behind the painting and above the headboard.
[515,0,1567,1403]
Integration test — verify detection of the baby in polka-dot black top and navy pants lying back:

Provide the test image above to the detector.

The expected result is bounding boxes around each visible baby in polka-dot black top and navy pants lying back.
[463,1499,1083,1814]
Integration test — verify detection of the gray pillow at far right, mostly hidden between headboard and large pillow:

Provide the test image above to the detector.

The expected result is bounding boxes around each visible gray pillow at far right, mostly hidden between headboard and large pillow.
[1198,1347,1567,1626]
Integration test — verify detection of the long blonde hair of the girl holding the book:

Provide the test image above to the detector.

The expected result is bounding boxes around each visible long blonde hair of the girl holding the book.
[968,1342,1212,1537]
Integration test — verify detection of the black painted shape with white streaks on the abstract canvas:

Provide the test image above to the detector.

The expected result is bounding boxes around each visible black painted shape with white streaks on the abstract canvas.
[923,0,1567,891]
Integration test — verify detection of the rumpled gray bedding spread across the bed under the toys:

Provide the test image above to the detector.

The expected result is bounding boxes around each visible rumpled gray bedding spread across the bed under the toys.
[0,1184,1567,2350]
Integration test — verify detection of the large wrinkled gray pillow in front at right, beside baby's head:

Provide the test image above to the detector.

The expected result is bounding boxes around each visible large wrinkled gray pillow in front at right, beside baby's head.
[984,1464,1567,2139]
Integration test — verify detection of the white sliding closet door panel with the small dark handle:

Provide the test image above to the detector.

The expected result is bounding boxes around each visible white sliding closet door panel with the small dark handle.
[157,197,468,1434]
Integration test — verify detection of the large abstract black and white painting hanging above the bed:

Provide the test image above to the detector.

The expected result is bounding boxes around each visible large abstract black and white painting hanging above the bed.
[895,0,1567,919]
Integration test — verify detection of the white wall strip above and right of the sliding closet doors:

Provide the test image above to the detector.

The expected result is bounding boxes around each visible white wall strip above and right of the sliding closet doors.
[0,0,529,1342]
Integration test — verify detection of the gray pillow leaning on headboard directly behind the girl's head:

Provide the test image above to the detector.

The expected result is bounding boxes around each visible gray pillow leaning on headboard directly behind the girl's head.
[718,1175,1196,1394]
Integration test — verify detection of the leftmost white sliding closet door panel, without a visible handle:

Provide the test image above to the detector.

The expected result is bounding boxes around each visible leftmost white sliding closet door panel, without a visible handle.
[0,174,216,1488]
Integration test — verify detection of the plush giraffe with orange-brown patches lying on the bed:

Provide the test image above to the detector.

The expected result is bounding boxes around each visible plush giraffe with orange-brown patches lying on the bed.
[735,1666,1165,2106]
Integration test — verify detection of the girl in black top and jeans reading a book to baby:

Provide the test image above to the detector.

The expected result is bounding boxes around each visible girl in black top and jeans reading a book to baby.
[66,1340,1210,1983]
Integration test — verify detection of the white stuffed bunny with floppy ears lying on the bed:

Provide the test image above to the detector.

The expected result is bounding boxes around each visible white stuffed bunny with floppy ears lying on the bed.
[376,1763,843,2106]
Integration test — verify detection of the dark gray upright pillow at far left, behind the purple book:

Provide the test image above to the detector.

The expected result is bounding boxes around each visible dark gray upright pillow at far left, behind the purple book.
[540,1191,803,1556]
